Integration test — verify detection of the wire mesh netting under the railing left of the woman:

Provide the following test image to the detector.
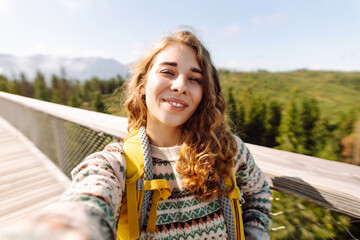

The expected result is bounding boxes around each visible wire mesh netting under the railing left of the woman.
[0,98,120,178]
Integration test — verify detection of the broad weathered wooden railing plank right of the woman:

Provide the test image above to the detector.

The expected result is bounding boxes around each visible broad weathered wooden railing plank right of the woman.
[246,144,360,218]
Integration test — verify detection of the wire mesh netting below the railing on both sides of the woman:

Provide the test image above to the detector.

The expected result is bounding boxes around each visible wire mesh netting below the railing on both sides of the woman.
[0,93,360,239]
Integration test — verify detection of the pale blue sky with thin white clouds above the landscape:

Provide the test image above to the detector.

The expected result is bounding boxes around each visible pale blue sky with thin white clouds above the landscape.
[0,0,360,71]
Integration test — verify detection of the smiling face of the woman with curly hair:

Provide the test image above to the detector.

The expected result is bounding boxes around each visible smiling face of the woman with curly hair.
[145,44,203,127]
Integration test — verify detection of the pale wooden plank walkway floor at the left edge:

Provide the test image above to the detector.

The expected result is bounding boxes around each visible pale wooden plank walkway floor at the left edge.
[0,117,70,226]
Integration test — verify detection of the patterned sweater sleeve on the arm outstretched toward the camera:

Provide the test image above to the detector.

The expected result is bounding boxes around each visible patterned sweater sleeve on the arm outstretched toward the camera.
[0,143,126,240]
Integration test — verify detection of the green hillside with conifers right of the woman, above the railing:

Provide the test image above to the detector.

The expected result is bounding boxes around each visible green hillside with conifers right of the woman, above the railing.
[220,70,360,165]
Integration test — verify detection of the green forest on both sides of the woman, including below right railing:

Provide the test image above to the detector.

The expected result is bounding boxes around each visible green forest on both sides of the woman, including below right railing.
[0,69,360,239]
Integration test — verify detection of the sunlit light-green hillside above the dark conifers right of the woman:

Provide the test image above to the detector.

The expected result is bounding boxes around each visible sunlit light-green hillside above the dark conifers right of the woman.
[220,70,360,122]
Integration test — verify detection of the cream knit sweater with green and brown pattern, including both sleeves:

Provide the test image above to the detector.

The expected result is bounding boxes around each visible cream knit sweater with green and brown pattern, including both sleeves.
[0,137,272,240]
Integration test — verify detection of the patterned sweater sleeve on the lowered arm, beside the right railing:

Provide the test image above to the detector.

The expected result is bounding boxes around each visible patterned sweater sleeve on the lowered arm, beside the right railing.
[235,137,272,240]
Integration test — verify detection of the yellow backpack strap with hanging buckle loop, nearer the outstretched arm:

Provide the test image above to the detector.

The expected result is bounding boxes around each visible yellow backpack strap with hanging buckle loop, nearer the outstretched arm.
[117,127,171,239]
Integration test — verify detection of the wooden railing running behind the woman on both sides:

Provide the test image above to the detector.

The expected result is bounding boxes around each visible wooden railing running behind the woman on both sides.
[0,92,360,218]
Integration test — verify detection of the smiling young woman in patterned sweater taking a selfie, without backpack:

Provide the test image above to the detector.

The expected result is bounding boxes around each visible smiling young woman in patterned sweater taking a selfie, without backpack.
[2,31,271,239]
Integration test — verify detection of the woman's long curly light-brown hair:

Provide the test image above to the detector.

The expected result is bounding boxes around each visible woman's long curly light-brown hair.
[125,30,237,201]
